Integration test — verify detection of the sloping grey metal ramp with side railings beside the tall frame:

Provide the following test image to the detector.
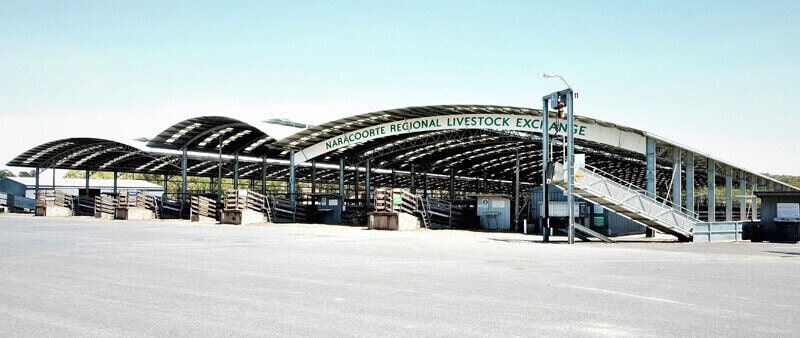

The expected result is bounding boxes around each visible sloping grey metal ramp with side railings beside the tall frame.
[552,166,700,241]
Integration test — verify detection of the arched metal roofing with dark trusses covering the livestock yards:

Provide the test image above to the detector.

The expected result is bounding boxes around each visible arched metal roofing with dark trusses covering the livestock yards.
[8,105,797,197]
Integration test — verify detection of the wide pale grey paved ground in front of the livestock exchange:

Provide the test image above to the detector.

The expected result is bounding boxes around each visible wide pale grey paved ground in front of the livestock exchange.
[0,216,800,336]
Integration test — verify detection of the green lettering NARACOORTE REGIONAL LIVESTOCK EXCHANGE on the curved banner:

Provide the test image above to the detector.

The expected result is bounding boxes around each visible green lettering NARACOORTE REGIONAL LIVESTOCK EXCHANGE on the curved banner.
[325,115,586,149]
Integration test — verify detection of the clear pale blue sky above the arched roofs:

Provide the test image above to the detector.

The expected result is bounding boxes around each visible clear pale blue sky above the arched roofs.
[0,0,800,175]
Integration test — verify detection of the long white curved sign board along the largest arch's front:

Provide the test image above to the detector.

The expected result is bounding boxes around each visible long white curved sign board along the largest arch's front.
[294,114,646,165]
